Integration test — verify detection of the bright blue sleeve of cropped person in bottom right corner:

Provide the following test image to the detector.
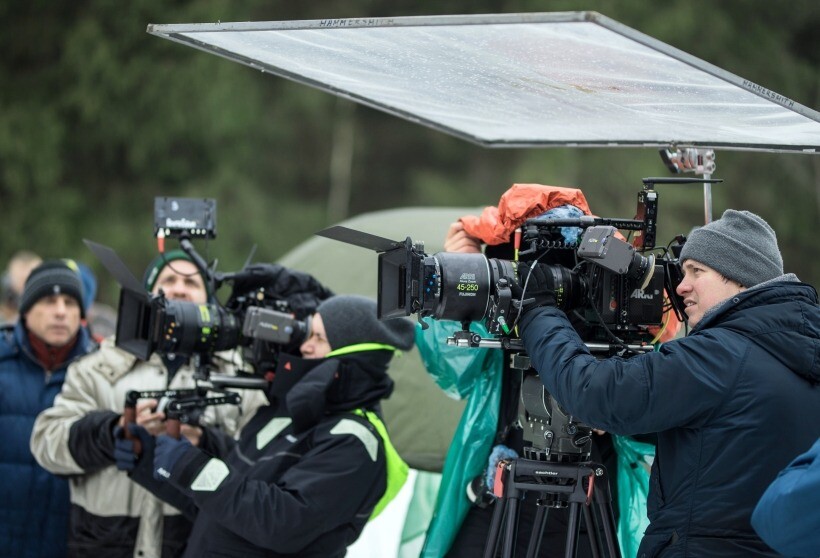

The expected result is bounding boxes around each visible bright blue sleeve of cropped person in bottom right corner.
[752,438,820,558]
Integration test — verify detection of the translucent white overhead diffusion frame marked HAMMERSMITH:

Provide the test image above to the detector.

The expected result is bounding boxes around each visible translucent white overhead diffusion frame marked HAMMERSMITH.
[148,12,820,154]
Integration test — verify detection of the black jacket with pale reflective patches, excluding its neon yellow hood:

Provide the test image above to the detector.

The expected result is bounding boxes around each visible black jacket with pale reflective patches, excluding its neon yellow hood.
[139,351,393,558]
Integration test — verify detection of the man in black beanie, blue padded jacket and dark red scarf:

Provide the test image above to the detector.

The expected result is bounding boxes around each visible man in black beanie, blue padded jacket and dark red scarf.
[0,260,94,558]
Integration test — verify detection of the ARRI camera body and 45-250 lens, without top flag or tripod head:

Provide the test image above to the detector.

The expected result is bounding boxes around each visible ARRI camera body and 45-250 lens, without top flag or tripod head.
[378,212,683,343]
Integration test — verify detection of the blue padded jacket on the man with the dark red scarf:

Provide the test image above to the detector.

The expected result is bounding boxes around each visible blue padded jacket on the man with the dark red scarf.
[0,323,93,558]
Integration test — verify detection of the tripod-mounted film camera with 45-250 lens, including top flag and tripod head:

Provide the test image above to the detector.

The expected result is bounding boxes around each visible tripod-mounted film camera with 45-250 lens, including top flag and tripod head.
[318,178,705,461]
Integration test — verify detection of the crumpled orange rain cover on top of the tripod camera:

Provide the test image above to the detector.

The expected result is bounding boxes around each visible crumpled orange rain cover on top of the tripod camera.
[460,184,592,245]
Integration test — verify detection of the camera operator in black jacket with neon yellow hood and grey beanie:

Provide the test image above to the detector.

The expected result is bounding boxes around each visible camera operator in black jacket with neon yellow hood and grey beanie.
[129,295,415,558]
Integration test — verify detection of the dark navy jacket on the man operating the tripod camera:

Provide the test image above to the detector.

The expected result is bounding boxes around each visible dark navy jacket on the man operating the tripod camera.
[521,276,820,558]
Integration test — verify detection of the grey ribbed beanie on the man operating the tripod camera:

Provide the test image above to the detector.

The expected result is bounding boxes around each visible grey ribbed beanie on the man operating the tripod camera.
[680,209,783,288]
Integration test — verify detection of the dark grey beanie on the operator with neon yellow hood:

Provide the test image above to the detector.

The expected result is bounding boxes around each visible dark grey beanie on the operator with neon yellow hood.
[316,295,415,350]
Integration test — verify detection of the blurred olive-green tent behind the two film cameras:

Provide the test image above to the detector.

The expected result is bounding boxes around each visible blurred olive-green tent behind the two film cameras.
[279,207,481,472]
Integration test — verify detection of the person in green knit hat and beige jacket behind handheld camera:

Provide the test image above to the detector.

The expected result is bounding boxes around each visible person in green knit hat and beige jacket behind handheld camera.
[31,250,265,558]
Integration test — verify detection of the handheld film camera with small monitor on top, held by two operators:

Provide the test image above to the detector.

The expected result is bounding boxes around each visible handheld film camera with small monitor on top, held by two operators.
[86,198,332,384]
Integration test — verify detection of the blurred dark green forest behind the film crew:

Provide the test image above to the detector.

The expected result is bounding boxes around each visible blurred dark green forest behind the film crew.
[0,0,820,305]
